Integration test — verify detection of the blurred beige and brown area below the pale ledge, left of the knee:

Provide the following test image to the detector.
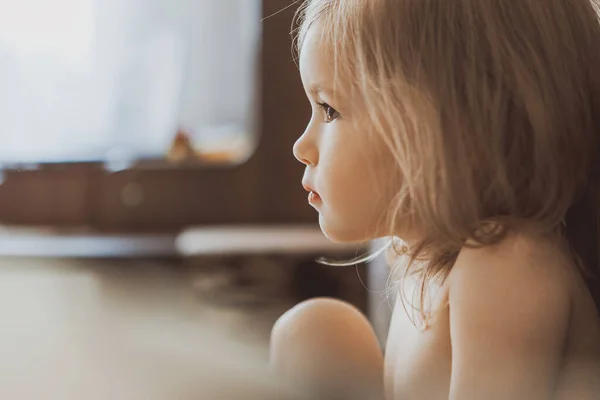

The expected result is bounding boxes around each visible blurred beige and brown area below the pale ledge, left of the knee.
[0,255,366,400]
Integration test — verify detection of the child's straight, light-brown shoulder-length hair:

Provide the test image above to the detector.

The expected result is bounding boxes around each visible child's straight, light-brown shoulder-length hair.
[294,0,600,324]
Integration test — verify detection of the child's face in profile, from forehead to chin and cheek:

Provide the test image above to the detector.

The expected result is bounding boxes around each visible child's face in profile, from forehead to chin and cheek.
[294,25,393,242]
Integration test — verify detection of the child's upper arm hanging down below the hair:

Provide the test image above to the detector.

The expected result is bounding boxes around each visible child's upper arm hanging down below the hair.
[449,250,570,400]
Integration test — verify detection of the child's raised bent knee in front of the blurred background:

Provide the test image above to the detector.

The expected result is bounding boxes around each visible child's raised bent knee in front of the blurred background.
[271,299,383,400]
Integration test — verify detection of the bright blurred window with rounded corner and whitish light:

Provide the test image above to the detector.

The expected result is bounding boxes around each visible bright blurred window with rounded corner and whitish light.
[0,0,261,165]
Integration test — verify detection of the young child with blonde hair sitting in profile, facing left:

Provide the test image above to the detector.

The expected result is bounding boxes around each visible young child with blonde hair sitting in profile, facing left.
[271,0,600,400]
